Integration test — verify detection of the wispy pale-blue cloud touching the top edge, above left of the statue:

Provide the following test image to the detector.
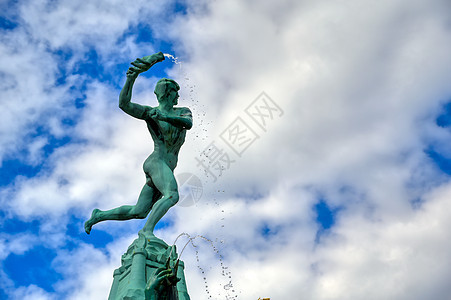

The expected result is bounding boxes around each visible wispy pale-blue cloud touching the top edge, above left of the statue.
[20,0,170,54]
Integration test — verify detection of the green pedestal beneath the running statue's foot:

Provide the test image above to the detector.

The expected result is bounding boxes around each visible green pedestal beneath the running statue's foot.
[108,231,190,300]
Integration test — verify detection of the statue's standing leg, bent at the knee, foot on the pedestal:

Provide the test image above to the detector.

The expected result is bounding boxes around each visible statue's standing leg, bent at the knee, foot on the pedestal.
[143,161,179,233]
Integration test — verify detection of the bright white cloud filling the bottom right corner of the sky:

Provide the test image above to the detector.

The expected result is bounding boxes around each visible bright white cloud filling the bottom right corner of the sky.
[313,184,451,299]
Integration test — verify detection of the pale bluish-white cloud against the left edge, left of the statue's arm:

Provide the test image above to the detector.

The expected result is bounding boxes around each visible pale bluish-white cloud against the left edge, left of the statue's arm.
[0,29,71,163]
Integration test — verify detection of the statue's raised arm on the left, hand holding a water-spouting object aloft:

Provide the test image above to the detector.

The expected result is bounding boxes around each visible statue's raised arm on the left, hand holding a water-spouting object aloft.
[119,52,164,120]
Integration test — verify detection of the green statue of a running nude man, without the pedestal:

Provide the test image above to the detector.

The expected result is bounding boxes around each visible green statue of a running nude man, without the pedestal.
[85,52,193,234]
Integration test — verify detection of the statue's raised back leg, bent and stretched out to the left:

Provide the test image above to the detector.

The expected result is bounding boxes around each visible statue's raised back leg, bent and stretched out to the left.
[85,184,161,234]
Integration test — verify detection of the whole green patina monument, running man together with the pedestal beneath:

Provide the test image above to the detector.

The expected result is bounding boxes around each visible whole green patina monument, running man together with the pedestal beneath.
[84,52,193,300]
